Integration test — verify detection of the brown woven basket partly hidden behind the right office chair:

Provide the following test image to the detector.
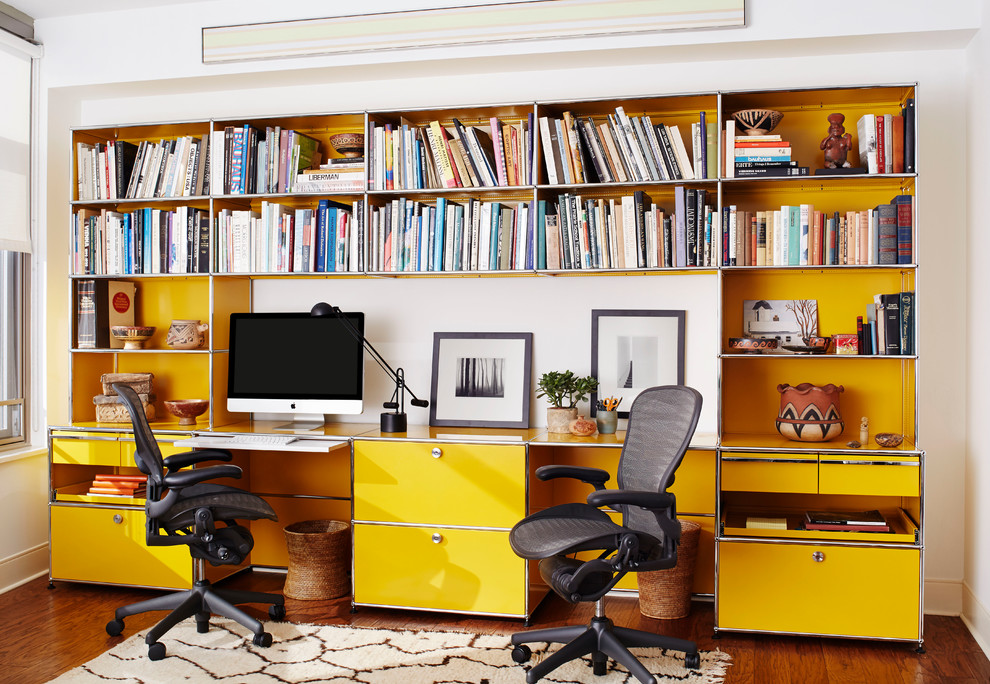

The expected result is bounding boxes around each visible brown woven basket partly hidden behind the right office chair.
[636,520,701,620]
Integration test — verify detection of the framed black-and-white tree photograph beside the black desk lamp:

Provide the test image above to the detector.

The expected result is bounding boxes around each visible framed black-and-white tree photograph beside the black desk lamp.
[430,333,533,428]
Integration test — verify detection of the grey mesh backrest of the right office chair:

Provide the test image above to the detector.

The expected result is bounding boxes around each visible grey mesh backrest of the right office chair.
[617,385,701,539]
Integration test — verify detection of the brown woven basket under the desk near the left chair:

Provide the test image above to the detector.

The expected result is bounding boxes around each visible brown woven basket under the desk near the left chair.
[282,520,351,600]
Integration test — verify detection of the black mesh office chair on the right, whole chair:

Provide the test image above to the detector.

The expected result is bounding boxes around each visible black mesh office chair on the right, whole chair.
[509,385,701,684]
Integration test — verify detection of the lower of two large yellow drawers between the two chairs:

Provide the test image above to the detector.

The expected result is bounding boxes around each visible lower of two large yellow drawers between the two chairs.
[354,524,528,616]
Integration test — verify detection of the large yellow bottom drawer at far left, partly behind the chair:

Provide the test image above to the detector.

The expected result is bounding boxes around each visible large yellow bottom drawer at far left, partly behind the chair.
[51,506,192,589]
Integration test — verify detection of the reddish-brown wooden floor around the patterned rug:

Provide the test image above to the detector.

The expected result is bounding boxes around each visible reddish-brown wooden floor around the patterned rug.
[0,572,990,684]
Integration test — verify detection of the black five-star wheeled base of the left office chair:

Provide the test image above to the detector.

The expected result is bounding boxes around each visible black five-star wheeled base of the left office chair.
[107,580,285,660]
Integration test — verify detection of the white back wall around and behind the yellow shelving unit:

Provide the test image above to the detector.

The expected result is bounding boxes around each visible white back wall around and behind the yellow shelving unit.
[25,0,990,640]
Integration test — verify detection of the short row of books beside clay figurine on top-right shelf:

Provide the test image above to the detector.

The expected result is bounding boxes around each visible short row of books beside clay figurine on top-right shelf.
[856,98,915,173]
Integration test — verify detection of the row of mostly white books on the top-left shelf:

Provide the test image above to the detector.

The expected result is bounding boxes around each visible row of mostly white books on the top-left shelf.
[76,136,209,201]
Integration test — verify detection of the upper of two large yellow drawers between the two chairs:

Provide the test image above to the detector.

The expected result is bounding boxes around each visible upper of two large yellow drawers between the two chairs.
[354,441,526,528]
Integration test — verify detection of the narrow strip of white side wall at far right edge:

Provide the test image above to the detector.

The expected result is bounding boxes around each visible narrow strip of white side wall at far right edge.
[958,0,990,653]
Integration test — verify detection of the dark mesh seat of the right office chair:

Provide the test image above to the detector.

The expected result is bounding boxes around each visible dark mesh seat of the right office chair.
[509,503,659,559]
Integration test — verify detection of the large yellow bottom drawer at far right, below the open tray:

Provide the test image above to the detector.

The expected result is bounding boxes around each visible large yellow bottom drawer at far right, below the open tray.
[716,542,921,640]
